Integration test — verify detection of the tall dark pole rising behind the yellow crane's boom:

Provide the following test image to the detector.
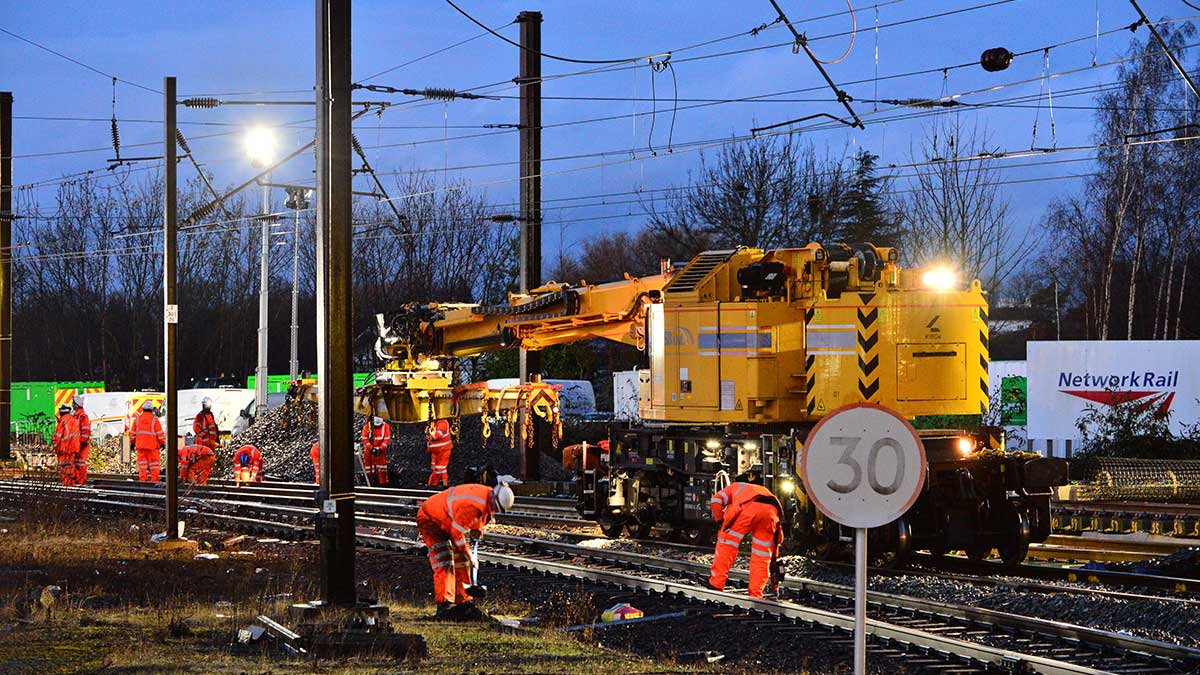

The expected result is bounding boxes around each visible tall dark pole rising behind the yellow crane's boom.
[517,12,546,480]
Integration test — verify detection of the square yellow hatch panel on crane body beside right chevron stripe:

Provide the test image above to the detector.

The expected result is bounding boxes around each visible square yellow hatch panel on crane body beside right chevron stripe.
[896,342,967,401]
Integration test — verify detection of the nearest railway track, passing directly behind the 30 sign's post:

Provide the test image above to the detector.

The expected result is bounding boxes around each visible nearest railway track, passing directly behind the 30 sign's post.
[0,482,1200,675]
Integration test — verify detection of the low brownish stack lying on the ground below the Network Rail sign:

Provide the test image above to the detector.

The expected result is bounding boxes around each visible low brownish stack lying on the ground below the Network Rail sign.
[1070,458,1200,503]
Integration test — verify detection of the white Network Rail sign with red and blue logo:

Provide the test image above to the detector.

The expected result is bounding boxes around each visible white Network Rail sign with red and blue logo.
[1027,340,1200,438]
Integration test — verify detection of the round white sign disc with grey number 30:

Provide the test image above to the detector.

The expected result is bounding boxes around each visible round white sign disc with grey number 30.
[800,404,925,527]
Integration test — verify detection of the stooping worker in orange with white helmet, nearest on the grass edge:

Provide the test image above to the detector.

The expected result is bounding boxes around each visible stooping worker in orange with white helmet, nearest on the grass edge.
[416,483,515,619]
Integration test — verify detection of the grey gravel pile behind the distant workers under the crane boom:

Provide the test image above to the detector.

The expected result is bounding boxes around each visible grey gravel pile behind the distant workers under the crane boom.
[225,401,568,488]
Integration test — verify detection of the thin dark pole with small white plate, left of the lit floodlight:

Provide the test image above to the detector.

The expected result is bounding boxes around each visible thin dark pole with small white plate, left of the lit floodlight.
[162,77,179,539]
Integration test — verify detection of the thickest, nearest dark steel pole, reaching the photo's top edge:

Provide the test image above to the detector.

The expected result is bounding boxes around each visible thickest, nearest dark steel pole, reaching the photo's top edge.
[316,0,358,607]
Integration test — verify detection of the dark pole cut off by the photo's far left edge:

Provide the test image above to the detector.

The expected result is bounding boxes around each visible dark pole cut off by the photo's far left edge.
[0,91,13,460]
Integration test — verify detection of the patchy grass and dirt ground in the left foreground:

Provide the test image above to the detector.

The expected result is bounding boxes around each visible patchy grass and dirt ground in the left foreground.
[0,504,727,675]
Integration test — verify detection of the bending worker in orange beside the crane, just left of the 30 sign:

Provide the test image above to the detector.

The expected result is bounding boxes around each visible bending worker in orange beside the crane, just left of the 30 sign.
[708,483,784,598]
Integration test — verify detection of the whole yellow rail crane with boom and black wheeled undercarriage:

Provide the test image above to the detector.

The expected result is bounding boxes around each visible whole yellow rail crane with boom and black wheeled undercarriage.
[360,244,1067,565]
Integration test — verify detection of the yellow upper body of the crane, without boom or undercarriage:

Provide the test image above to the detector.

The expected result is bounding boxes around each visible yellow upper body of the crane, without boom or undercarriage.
[641,245,988,424]
